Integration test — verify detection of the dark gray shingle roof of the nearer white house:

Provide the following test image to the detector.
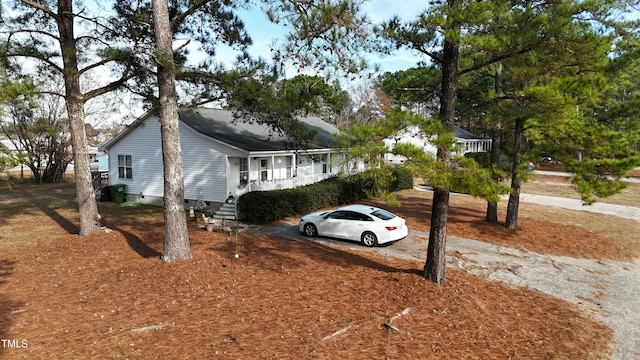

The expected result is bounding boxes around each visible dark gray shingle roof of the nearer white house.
[100,108,339,152]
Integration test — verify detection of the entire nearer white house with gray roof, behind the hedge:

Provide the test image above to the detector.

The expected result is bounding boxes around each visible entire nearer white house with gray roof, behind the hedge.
[100,108,363,209]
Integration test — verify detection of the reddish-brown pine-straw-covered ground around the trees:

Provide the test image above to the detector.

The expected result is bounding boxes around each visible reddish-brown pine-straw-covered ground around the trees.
[0,173,640,359]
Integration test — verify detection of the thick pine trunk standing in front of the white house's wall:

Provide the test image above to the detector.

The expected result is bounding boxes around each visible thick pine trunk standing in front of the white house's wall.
[153,0,191,263]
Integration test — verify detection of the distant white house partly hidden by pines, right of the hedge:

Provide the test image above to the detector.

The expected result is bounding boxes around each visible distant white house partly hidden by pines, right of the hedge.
[383,126,491,163]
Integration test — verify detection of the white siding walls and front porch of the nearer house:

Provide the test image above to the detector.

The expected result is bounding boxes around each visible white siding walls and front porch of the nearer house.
[105,111,363,209]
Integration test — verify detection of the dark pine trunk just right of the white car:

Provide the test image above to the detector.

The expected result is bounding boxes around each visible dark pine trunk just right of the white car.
[423,0,461,285]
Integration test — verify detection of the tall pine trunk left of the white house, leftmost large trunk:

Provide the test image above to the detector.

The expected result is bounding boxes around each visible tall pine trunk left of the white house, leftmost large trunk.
[57,0,100,235]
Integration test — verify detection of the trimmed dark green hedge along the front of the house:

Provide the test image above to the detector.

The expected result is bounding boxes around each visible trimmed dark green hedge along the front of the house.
[238,168,413,223]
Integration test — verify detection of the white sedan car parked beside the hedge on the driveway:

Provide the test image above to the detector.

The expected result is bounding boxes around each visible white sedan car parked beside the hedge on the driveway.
[298,205,409,246]
